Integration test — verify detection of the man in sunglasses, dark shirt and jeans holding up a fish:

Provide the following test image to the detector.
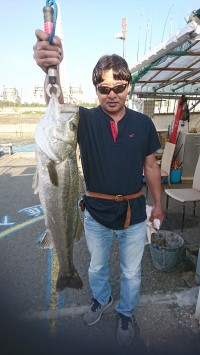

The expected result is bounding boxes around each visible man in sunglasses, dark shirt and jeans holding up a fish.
[34,30,163,346]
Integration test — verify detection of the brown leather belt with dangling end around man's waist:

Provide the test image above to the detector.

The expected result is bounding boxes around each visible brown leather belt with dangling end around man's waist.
[86,191,142,229]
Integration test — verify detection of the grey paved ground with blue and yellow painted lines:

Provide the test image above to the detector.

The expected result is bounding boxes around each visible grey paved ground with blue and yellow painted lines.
[0,153,200,355]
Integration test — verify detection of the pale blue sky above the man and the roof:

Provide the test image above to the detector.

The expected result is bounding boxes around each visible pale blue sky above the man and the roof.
[0,0,200,101]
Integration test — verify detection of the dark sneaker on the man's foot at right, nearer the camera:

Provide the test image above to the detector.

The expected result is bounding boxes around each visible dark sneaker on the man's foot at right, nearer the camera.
[117,313,135,346]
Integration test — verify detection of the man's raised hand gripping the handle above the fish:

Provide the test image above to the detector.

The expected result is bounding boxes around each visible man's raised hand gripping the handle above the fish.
[33,30,63,73]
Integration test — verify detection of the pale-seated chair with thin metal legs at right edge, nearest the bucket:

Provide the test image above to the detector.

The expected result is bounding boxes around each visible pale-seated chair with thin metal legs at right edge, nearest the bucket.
[165,156,200,232]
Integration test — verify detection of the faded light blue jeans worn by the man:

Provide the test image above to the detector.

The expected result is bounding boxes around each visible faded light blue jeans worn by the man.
[84,210,146,317]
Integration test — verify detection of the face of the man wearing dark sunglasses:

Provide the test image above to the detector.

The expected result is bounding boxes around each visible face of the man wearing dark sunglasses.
[96,69,129,116]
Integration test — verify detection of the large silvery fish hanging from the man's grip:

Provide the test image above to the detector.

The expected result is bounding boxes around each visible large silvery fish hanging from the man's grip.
[33,95,84,291]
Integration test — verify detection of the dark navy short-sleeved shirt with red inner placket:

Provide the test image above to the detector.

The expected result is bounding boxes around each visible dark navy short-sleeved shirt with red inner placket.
[78,106,160,230]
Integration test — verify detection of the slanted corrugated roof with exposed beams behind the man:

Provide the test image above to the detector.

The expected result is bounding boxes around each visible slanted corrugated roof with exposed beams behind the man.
[131,10,200,98]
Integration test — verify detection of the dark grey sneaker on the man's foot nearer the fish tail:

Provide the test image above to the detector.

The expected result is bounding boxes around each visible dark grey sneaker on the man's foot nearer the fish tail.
[83,296,113,325]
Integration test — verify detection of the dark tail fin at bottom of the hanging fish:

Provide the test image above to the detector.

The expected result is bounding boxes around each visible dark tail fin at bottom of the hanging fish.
[56,270,83,292]
